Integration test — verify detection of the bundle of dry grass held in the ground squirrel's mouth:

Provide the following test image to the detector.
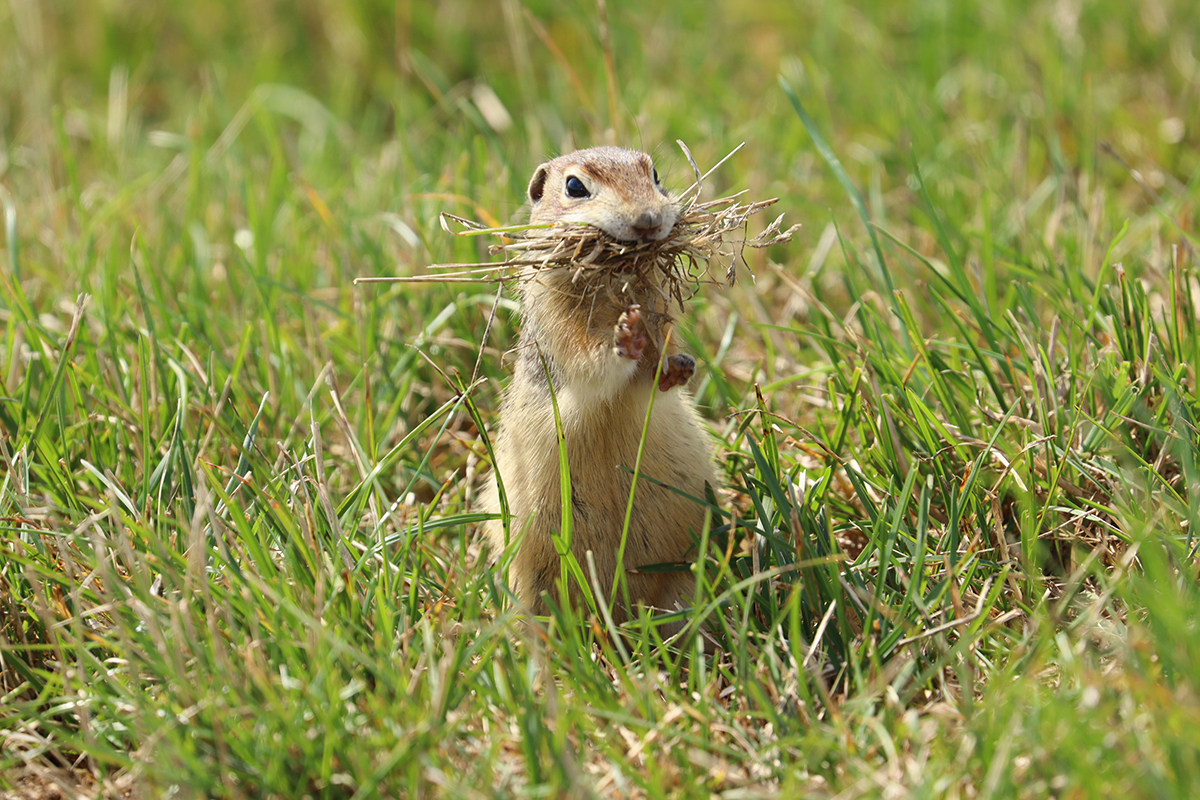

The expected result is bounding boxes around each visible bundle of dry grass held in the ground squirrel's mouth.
[355,142,800,308]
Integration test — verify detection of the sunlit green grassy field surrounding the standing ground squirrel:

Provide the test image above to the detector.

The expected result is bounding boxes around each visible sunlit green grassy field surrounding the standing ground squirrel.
[0,0,1200,799]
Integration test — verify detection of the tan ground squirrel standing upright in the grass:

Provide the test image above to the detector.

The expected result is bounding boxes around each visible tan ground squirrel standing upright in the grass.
[485,148,715,632]
